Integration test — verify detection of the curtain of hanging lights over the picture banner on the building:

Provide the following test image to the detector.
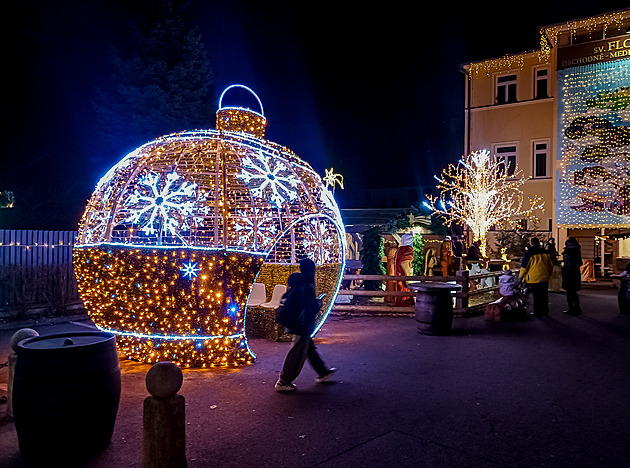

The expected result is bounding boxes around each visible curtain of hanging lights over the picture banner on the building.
[556,60,630,227]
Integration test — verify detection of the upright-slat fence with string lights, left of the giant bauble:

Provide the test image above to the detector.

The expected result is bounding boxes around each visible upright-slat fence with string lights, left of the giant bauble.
[0,229,81,315]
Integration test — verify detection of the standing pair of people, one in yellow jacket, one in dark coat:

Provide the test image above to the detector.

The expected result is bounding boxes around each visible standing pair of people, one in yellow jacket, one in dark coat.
[519,237,582,317]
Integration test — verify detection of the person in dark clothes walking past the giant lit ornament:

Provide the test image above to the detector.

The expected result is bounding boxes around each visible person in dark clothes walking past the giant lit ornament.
[275,258,336,392]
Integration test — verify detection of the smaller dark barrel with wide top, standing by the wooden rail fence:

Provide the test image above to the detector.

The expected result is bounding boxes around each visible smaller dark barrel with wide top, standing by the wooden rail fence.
[409,282,461,335]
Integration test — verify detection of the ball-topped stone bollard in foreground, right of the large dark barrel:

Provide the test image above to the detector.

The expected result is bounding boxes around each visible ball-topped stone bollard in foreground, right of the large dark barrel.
[142,362,186,468]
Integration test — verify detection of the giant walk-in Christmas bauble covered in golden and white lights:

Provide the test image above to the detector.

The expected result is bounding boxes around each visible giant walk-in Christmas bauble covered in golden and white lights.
[74,85,345,367]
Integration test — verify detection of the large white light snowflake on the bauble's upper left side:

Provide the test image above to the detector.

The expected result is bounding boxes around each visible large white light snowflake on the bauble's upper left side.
[124,171,197,240]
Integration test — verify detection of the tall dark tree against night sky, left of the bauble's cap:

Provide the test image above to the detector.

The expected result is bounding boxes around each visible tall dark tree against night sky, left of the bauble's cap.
[94,0,215,151]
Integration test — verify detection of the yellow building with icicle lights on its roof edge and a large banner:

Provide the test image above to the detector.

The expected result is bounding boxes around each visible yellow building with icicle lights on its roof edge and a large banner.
[463,9,630,274]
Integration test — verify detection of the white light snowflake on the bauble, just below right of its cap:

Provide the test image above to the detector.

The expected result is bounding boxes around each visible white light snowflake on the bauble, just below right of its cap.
[236,152,299,208]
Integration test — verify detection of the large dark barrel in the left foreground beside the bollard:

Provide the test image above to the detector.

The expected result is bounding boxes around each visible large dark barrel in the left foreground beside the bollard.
[13,331,120,466]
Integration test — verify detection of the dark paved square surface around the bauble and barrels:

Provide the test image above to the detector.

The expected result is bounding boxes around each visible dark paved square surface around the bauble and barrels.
[0,289,630,468]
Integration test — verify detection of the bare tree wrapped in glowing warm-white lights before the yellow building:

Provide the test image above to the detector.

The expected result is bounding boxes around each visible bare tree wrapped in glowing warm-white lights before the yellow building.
[424,150,544,255]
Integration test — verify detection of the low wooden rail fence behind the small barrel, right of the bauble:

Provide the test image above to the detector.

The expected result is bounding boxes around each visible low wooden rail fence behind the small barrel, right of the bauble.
[332,270,518,315]
